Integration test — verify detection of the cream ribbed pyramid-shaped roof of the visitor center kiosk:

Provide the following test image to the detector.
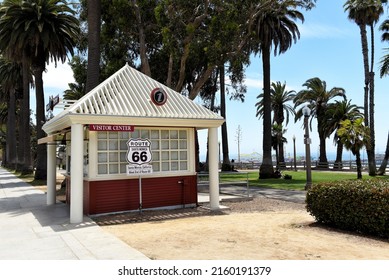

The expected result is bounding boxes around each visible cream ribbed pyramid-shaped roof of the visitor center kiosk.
[43,64,224,133]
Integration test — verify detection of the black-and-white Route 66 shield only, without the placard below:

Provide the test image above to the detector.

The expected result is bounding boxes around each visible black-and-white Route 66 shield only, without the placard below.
[127,138,152,165]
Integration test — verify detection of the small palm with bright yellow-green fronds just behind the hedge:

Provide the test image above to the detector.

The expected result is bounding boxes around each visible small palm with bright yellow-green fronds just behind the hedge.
[338,118,370,179]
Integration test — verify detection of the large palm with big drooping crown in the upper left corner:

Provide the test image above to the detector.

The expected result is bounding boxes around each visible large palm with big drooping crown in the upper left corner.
[0,0,79,179]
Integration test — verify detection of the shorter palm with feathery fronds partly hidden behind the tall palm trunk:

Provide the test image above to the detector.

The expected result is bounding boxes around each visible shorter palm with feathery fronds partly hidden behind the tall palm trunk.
[255,81,296,167]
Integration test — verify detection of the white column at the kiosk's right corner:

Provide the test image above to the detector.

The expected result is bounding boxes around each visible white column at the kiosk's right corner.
[208,127,220,210]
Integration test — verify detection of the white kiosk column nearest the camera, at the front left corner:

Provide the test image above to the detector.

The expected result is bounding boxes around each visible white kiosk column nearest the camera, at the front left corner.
[70,124,84,224]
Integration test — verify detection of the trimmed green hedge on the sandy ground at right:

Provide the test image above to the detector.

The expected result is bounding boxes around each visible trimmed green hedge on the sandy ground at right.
[306,179,389,238]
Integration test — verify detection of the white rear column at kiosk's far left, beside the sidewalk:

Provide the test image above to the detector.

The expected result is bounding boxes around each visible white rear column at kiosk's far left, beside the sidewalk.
[46,142,57,205]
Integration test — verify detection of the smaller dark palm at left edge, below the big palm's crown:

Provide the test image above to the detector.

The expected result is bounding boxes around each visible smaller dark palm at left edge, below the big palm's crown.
[0,58,23,169]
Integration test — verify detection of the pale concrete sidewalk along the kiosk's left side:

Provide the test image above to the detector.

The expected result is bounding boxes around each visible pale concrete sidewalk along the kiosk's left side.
[0,168,148,260]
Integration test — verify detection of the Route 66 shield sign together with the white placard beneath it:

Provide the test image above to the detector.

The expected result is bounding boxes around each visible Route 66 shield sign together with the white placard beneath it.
[127,138,153,175]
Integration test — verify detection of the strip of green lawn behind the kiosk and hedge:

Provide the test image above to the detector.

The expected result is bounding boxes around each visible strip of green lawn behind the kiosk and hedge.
[215,170,388,190]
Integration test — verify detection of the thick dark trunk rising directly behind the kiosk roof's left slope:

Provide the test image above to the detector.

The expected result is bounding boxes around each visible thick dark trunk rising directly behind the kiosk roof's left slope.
[86,0,101,92]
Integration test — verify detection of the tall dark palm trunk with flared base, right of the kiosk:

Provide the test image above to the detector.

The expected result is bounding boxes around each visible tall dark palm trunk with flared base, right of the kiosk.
[259,46,274,179]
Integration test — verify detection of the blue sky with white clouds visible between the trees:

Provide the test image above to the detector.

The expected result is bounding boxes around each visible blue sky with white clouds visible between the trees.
[41,0,389,160]
